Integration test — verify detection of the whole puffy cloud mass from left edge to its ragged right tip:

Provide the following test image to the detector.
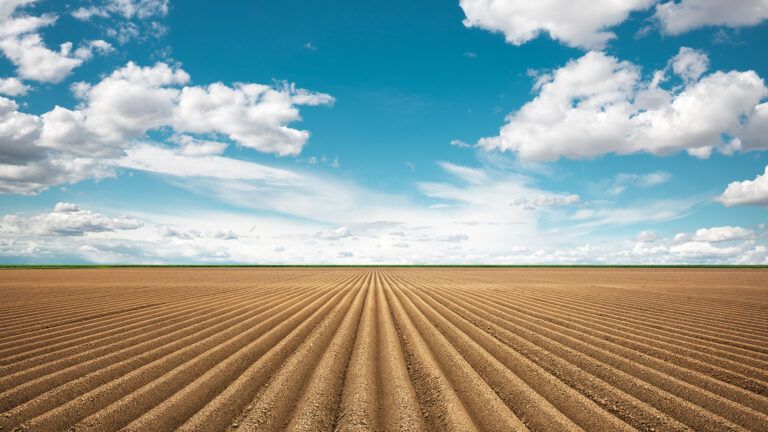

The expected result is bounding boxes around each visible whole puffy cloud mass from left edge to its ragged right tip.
[0,62,333,194]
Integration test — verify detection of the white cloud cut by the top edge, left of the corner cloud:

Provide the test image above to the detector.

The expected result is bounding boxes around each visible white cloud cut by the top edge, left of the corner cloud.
[459,0,655,49]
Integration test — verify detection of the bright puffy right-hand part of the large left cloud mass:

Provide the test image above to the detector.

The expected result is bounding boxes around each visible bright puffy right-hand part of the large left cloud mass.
[60,62,333,155]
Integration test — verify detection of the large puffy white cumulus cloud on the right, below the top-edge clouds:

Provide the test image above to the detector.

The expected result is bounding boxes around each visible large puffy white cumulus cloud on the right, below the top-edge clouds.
[478,50,768,161]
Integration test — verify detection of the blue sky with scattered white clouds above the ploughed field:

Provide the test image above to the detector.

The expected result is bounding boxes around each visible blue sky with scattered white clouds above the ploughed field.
[0,0,768,264]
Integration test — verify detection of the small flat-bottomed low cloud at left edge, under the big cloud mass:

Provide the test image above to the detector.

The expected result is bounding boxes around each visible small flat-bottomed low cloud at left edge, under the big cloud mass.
[0,202,143,236]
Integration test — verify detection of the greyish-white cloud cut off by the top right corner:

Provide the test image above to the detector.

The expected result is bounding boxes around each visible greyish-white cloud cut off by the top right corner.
[655,0,768,35]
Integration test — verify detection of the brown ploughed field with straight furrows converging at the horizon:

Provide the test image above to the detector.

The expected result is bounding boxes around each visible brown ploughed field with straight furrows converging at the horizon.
[0,268,768,432]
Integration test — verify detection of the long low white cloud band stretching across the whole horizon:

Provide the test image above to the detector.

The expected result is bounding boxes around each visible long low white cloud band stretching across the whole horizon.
[0,198,768,264]
